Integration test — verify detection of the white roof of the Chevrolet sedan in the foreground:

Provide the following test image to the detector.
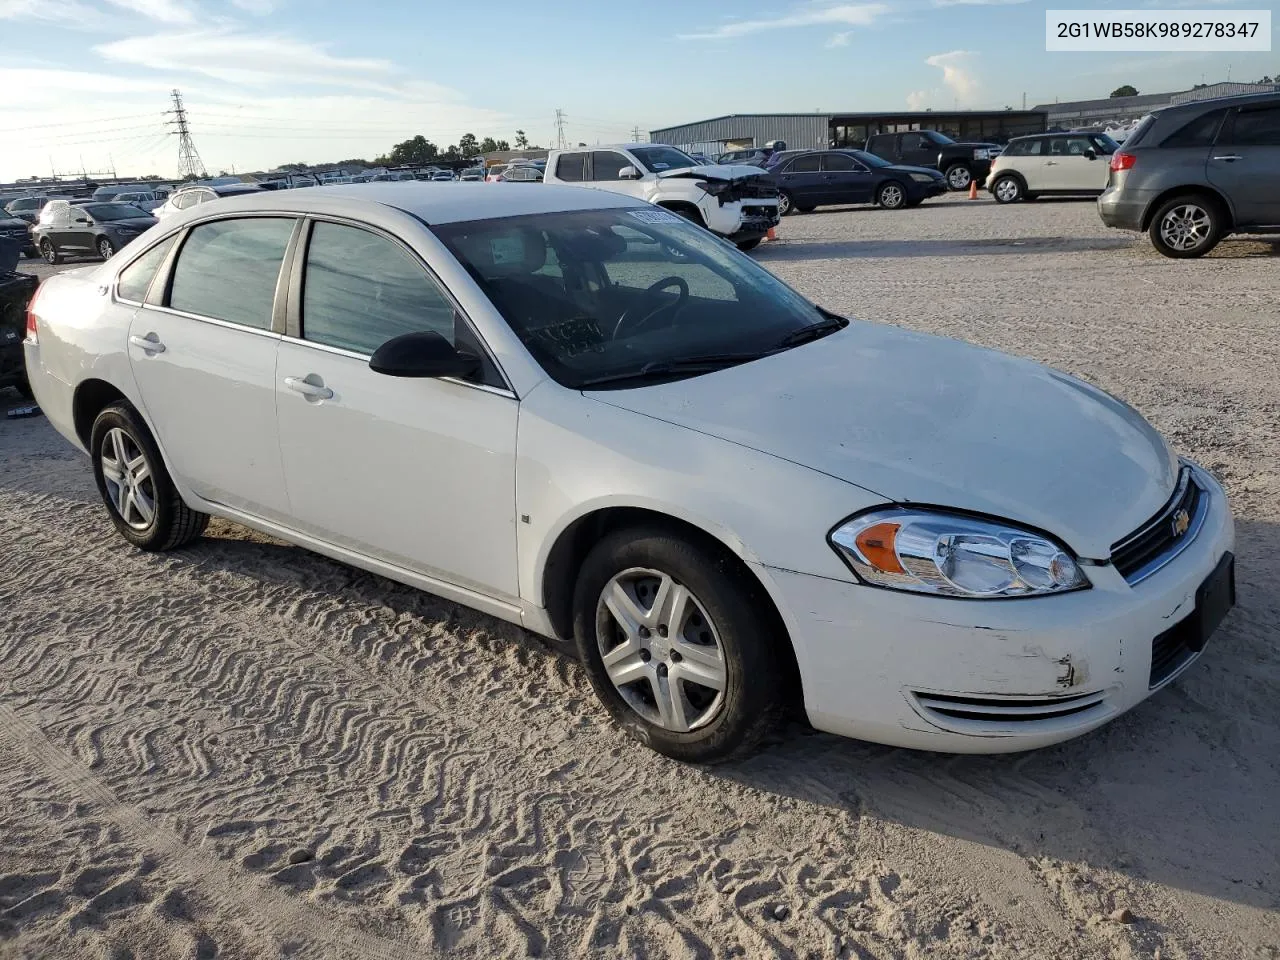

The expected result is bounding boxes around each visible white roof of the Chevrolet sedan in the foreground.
[170,180,648,224]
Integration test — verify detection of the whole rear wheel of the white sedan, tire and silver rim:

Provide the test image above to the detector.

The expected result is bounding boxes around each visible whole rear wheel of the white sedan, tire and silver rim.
[90,402,209,550]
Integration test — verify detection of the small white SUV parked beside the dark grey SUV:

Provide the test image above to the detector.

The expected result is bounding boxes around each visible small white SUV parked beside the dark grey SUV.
[987,133,1120,204]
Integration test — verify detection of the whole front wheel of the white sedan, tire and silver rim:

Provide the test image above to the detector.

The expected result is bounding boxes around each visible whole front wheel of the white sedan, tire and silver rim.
[573,526,785,763]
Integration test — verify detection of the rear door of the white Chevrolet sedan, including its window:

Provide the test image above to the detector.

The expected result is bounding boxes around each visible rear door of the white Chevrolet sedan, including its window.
[122,216,297,520]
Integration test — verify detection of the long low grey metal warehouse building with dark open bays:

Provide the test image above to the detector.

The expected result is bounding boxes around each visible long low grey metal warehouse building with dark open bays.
[649,109,1048,155]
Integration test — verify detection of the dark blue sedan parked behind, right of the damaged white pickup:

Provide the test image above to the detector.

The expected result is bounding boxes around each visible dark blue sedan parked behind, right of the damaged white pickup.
[768,150,947,216]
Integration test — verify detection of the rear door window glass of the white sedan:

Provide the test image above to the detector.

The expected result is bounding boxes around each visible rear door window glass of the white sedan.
[169,218,293,330]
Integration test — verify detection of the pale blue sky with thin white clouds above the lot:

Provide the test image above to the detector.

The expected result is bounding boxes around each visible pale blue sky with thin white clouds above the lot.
[0,0,1280,180]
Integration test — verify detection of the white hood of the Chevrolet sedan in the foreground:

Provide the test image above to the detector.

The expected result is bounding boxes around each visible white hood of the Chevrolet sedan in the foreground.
[588,321,1178,559]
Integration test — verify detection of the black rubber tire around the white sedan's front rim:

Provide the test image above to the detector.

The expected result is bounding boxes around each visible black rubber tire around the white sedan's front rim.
[573,526,787,763]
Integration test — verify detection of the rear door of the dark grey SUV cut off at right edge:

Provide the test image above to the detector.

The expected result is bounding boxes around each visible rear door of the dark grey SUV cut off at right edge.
[1207,102,1280,227]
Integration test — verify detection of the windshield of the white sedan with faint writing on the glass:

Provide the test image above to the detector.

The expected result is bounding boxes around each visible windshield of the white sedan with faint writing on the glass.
[431,207,829,389]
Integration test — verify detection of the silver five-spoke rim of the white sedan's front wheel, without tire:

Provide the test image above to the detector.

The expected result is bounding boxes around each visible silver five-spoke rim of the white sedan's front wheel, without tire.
[595,567,728,733]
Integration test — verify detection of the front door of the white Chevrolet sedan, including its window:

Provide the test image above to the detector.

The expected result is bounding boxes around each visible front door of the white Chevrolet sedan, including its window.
[275,221,520,599]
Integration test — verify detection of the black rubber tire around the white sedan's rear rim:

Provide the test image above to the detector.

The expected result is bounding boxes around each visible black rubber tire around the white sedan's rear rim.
[90,401,209,550]
